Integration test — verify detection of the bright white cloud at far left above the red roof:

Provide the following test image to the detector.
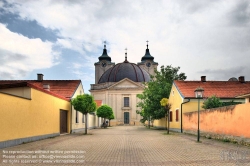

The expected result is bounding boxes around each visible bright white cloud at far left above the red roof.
[0,23,58,79]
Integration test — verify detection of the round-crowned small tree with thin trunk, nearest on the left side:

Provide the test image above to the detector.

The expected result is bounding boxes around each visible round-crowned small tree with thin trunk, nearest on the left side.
[71,94,96,134]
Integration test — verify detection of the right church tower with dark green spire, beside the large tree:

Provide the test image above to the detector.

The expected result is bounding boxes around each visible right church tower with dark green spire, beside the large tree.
[137,41,158,75]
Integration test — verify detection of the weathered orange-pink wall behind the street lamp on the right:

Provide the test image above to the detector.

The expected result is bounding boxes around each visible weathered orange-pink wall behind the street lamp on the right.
[183,103,250,138]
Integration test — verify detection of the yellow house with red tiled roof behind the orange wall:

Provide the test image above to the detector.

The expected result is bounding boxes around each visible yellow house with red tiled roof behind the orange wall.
[154,76,250,131]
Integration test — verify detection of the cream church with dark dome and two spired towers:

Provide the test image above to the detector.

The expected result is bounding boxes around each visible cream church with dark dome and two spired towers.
[90,44,158,126]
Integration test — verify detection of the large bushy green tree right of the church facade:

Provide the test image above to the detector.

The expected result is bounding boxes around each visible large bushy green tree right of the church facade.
[137,65,187,124]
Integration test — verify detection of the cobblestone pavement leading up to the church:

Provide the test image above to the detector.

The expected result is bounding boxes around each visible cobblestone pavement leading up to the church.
[0,126,250,166]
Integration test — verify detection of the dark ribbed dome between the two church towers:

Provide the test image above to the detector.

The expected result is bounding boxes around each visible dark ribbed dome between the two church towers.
[98,60,150,84]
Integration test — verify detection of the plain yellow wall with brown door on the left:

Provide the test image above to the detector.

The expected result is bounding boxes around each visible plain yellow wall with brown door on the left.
[0,89,71,141]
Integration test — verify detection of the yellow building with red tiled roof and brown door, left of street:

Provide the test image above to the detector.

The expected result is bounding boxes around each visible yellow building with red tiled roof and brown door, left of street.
[0,74,98,148]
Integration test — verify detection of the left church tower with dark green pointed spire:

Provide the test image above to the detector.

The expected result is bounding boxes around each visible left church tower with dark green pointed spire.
[95,42,115,84]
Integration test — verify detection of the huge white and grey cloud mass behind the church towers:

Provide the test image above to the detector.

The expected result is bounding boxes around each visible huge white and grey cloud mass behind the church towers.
[2,0,250,79]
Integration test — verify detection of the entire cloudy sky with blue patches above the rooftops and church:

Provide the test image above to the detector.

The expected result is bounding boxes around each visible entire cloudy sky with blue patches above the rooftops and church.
[0,0,250,93]
